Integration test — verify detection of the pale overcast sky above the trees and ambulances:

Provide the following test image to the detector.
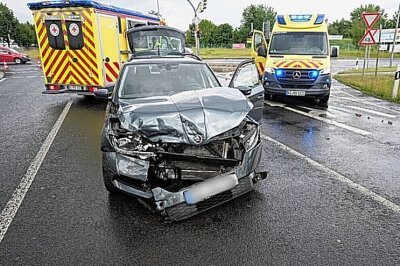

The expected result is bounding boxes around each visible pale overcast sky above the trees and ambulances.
[0,0,399,30]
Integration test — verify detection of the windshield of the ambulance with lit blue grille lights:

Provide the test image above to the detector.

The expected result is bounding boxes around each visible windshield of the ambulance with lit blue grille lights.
[269,32,328,55]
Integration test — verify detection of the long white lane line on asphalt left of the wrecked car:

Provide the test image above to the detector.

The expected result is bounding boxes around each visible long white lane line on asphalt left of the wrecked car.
[0,99,73,244]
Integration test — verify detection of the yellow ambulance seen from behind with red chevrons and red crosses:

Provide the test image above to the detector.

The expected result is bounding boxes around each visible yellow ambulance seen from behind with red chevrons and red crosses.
[28,0,160,95]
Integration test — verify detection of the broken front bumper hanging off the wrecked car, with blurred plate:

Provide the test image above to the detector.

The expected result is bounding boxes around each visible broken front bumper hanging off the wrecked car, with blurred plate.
[105,142,266,221]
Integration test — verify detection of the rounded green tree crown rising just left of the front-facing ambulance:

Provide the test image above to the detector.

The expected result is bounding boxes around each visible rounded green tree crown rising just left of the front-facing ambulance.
[241,5,276,31]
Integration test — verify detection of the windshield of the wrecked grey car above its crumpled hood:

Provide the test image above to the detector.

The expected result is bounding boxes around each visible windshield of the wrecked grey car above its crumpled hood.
[118,63,220,99]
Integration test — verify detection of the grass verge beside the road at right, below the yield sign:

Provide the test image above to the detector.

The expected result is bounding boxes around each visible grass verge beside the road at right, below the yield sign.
[334,75,400,103]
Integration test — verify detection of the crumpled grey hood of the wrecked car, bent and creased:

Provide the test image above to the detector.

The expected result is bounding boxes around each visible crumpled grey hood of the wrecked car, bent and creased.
[118,88,253,145]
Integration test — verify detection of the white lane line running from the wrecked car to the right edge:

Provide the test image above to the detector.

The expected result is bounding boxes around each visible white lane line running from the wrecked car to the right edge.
[261,135,400,214]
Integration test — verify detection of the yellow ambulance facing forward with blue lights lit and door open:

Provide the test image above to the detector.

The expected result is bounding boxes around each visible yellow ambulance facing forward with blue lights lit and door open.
[252,14,332,103]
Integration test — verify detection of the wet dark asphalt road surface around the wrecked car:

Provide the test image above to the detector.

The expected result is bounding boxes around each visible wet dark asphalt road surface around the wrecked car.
[0,61,400,265]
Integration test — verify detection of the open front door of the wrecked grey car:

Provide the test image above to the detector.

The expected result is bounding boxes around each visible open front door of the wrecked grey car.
[229,60,264,122]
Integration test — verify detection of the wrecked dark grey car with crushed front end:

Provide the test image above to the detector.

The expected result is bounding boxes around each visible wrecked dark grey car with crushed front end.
[96,56,266,221]
